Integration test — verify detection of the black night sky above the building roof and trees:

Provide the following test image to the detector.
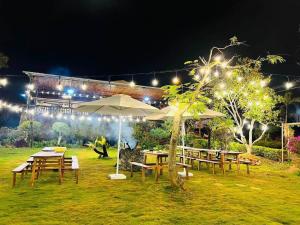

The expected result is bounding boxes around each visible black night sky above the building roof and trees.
[0,0,300,106]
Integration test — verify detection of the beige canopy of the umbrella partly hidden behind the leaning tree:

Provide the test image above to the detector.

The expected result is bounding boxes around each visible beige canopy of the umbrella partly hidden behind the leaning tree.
[146,106,225,120]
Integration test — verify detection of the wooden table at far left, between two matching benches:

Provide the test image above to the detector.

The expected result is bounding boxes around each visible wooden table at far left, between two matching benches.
[31,151,65,186]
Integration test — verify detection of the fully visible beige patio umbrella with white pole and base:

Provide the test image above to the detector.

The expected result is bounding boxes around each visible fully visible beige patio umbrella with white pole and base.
[75,94,159,179]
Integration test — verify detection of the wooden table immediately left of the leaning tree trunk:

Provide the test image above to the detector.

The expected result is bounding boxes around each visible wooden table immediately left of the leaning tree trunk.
[143,150,168,181]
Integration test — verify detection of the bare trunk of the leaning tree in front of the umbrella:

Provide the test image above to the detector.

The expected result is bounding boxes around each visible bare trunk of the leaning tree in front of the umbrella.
[168,111,182,187]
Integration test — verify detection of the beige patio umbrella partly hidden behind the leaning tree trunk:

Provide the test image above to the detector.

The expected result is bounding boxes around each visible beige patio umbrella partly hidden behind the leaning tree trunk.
[146,106,225,177]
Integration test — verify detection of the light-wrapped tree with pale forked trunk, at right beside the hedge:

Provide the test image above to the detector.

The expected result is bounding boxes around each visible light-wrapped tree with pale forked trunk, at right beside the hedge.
[213,55,283,154]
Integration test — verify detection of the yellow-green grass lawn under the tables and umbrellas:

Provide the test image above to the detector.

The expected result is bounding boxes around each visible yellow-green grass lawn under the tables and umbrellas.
[0,149,300,225]
